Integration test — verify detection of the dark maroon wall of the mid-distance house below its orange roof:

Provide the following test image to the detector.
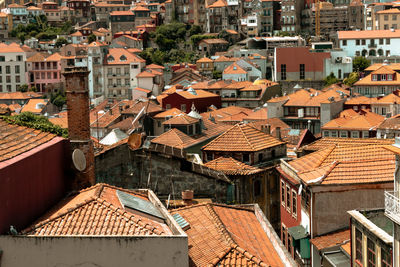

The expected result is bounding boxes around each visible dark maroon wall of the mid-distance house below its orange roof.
[162,93,221,113]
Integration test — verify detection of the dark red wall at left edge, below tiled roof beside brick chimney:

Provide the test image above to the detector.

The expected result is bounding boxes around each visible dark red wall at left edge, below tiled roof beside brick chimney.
[0,137,70,234]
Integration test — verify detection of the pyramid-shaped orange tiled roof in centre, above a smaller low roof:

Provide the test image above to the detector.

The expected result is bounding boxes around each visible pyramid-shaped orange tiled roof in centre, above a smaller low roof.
[202,124,284,151]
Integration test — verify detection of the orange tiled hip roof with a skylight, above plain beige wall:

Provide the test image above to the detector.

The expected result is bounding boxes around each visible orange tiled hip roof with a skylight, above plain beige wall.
[22,184,171,236]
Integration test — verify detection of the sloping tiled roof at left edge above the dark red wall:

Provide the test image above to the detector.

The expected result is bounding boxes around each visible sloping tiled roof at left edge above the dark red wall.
[0,120,57,162]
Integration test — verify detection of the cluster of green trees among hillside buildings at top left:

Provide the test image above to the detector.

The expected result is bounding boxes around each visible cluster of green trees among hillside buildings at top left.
[10,15,73,42]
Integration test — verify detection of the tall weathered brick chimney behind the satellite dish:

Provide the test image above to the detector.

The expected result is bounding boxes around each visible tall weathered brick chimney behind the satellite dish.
[62,67,95,190]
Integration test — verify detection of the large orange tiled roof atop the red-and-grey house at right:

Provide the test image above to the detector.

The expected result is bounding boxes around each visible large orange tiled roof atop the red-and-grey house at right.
[288,144,395,185]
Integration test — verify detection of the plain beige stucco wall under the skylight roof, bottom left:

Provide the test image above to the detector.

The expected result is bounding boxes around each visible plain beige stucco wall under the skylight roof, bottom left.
[0,236,188,267]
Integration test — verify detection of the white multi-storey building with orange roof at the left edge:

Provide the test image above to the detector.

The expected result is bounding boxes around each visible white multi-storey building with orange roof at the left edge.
[0,43,30,92]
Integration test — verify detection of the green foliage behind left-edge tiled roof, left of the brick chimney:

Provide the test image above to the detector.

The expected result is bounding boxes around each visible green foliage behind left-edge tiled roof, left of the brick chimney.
[0,112,68,138]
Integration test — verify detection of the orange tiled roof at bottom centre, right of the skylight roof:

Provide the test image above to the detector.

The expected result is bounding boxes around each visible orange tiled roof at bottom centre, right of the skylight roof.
[172,204,284,266]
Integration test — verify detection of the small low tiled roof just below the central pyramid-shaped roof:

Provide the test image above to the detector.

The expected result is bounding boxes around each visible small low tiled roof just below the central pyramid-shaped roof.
[204,157,263,175]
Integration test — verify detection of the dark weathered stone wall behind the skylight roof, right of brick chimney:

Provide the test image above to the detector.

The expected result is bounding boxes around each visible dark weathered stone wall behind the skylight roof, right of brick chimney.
[95,144,230,203]
